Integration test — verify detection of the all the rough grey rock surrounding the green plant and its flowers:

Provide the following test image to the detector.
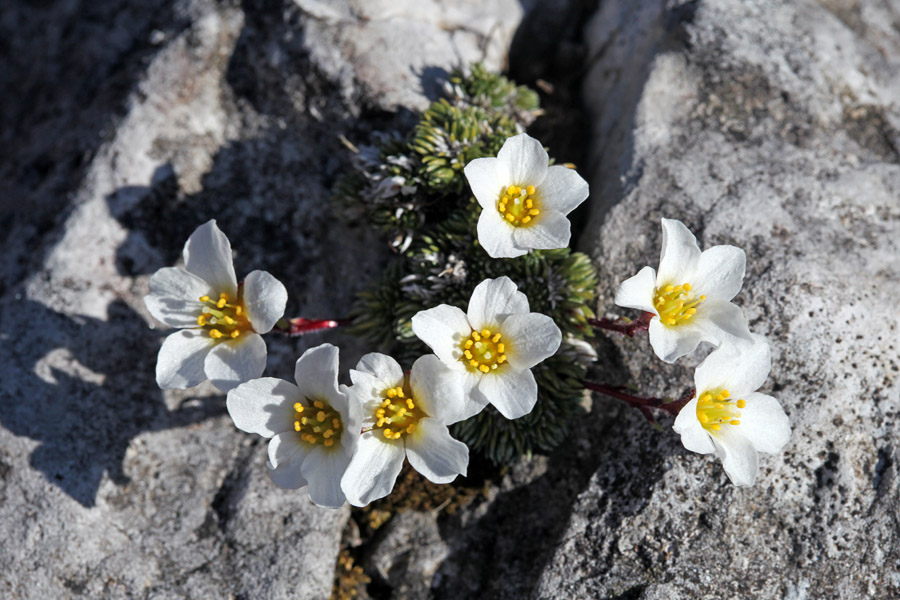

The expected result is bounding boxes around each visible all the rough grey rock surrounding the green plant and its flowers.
[0,0,900,599]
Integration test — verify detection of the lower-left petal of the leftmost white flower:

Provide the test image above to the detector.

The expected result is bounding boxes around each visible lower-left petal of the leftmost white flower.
[156,329,215,390]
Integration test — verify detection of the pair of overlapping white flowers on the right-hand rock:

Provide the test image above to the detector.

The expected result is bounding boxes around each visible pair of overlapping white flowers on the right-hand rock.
[616,219,791,486]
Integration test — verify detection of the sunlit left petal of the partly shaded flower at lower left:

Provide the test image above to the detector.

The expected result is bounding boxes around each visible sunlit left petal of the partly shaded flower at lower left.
[225,377,301,437]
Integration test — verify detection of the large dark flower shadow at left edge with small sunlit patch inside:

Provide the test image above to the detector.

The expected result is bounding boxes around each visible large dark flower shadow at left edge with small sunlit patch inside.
[0,299,225,507]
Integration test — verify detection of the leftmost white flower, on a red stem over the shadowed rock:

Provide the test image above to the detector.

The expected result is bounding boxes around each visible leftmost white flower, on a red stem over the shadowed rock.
[144,220,287,391]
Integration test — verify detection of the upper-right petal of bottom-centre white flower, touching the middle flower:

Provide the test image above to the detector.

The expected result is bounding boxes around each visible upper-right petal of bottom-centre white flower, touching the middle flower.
[409,354,465,425]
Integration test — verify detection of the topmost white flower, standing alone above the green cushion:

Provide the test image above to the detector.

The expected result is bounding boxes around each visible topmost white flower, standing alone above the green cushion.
[464,133,588,258]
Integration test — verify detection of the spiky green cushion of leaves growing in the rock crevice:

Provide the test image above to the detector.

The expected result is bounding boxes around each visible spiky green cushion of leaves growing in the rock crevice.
[335,65,597,465]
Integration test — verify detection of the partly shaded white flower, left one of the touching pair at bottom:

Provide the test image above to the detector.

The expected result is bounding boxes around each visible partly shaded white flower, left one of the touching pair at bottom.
[226,344,362,508]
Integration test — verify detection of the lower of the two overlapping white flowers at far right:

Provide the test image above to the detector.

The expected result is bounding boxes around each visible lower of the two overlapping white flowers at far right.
[673,336,791,486]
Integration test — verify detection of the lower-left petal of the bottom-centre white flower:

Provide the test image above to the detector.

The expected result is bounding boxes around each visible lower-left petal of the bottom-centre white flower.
[341,432,406,506]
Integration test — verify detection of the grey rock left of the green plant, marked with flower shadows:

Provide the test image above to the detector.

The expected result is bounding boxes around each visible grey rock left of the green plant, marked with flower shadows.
[0,0,523,598]
